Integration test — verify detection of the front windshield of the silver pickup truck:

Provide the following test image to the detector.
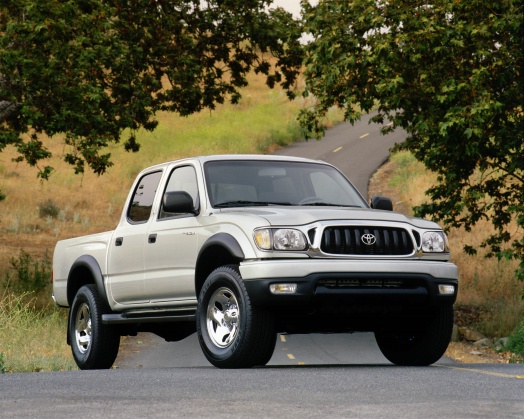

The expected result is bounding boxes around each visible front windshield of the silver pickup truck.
[204,160,367,208]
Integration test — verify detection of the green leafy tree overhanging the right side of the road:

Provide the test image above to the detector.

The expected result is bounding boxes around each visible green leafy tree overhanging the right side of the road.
[300,0,524,279]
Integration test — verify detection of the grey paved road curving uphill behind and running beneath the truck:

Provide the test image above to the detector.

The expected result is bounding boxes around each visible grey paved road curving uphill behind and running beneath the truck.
[0,116,524,419]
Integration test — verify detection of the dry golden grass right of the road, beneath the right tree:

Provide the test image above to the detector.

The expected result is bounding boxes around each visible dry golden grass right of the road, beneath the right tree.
[370,152,524,337]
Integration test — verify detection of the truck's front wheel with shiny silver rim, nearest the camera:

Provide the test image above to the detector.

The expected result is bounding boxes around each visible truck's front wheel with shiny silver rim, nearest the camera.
[197,266,277,368]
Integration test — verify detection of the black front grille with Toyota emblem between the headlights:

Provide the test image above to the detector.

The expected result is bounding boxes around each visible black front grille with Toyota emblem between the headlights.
[320,226,414,256]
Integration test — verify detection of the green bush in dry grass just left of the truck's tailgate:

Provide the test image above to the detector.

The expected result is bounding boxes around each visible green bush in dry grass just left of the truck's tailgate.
[5,250,52,294]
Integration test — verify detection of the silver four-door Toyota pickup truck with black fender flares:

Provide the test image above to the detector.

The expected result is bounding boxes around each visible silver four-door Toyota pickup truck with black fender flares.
[53,155,458,369]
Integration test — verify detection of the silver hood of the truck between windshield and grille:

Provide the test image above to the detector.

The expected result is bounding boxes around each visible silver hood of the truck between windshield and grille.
[221,206,440,230]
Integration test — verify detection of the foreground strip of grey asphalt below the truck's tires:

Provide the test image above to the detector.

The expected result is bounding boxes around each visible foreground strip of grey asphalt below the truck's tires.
[0,364,524,419]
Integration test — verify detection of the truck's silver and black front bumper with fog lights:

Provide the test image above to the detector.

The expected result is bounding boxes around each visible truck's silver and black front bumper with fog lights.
[240,259,458,308]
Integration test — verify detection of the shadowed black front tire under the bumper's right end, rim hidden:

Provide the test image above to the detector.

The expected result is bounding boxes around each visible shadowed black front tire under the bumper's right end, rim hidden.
[375,306,453,366]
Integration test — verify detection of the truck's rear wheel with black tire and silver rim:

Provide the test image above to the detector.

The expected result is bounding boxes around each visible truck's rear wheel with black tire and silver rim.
[68,285,120,370]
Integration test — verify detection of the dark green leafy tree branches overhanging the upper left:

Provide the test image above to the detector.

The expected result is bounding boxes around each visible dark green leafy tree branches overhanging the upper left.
[0,0,302,179]
